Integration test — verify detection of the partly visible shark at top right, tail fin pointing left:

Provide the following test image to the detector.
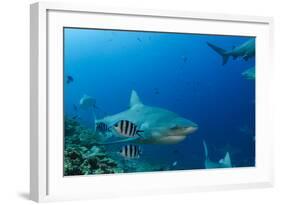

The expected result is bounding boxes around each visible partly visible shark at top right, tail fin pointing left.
[207,38,256,65]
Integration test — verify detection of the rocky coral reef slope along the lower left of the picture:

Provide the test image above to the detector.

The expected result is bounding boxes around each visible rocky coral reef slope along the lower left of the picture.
[64,117,166,176]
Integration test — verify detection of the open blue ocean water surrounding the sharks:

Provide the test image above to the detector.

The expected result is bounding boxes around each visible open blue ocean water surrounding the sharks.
[64,28,255,169]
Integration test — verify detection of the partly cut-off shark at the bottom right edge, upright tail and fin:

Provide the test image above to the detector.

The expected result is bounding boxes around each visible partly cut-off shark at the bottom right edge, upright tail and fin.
[203,140,232,169]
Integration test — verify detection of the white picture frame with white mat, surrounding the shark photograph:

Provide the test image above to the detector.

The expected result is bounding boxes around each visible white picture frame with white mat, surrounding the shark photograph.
[30,2,273,202]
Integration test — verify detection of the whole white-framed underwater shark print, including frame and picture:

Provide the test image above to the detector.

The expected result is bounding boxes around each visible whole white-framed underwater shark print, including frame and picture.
[30,3,273,201]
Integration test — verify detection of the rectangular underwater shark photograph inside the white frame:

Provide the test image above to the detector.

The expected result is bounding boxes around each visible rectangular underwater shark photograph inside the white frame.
[63,27,255,176]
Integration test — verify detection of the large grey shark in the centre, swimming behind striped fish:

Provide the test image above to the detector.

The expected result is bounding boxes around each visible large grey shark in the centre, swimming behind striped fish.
[97,90,198,144]
